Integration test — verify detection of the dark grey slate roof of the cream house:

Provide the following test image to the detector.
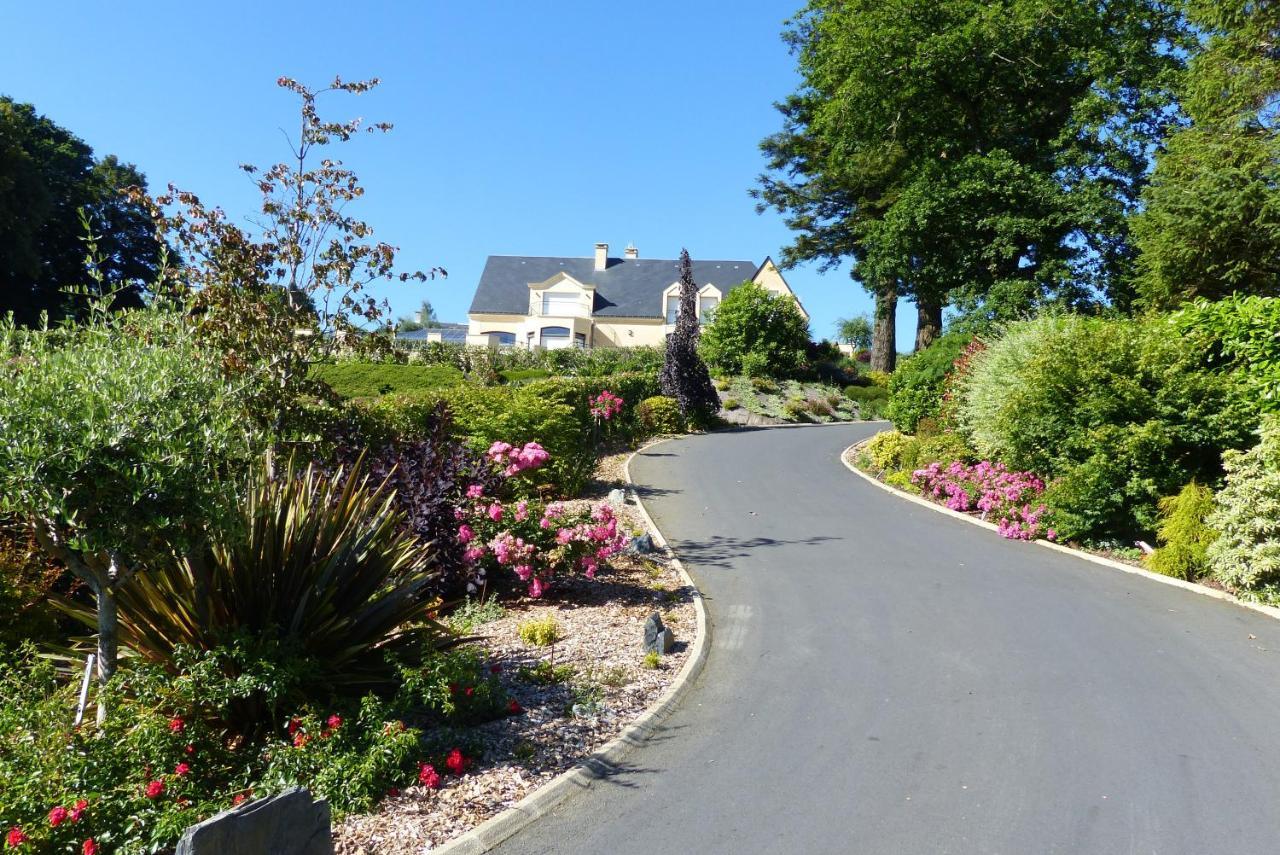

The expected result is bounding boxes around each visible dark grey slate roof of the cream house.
[470,255,760,317]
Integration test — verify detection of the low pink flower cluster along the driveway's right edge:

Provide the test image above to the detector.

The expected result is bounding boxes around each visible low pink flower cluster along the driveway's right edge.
[911,461,1057,540]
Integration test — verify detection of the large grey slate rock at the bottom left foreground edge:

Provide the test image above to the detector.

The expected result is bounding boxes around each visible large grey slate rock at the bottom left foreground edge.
[177,787,333,855]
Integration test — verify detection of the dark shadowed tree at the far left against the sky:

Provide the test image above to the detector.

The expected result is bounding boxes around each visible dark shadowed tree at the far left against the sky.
[0,97,163,325]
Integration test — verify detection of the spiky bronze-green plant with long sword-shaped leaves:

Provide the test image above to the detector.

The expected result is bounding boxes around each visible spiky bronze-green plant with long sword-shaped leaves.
[68,459,448,718]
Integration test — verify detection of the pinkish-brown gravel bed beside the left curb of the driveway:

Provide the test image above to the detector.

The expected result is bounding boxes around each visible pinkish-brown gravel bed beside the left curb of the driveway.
[334,491,696,855]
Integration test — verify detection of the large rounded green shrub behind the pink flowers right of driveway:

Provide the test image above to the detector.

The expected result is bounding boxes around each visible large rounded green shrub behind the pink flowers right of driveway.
[956,315,1258,543]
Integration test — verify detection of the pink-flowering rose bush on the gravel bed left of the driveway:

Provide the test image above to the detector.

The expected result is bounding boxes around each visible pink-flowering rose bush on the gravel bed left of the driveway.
[454,443,626,598]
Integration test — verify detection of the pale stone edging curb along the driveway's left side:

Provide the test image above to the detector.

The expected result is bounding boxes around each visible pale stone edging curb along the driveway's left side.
[431,436,710,855]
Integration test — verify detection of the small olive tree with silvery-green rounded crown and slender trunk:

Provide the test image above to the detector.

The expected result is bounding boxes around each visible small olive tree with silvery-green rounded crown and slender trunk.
[0,308,262,696]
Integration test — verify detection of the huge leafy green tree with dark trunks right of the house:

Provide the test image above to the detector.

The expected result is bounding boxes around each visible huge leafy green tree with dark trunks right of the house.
[758,0,1183,348]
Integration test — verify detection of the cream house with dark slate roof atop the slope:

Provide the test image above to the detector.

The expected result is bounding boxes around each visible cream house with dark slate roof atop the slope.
[467,243,809,349]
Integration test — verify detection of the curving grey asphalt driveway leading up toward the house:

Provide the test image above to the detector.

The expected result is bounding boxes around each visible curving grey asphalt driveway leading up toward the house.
[497,425,1280,855]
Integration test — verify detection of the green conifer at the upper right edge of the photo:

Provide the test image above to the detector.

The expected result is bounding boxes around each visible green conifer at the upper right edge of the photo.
[1133,0,1280,308]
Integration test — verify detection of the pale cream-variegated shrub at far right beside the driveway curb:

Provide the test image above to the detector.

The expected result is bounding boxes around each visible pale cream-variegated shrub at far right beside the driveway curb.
[1207,417,1280,593]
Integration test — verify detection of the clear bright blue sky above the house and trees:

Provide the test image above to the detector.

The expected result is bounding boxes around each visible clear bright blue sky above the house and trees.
[0,0,914,348]
